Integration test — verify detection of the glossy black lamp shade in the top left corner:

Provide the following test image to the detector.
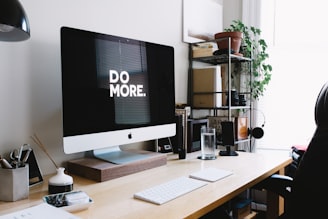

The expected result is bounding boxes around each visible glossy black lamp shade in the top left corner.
[0,0,30,42]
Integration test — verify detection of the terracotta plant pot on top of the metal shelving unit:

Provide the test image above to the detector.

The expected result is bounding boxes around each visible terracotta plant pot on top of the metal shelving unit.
[214,31,243,54]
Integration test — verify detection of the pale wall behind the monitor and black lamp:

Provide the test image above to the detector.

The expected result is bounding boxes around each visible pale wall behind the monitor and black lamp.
[0,0,188,174]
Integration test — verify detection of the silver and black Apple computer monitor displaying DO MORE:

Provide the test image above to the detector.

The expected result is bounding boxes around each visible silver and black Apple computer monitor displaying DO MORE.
[60,27,176,163]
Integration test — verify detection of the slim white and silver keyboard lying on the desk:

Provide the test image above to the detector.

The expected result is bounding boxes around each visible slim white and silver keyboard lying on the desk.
[134,177,207,205]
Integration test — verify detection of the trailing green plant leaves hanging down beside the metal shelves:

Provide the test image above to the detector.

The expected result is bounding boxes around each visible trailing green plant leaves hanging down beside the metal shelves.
[224,20,272,100]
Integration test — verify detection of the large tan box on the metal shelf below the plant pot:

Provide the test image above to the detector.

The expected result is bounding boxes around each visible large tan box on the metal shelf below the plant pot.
[193,66,222,108]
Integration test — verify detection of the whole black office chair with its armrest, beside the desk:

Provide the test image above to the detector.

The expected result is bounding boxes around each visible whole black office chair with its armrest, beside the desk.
[259,83,328,219]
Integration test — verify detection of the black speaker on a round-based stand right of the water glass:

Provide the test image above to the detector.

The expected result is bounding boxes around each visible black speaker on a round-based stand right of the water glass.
[219,121,238,156]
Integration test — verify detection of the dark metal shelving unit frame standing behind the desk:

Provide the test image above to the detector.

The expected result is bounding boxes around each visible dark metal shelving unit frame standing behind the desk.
[188,38,252,151]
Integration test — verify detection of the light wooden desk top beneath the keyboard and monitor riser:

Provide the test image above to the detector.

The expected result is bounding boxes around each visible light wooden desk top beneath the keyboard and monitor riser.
[0,152,291,219]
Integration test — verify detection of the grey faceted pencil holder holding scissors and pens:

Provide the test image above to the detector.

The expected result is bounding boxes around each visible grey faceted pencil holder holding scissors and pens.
[0,165,29,201]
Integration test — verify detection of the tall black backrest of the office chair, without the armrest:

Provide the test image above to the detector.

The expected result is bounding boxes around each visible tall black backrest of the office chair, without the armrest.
[289,83,328,218]
